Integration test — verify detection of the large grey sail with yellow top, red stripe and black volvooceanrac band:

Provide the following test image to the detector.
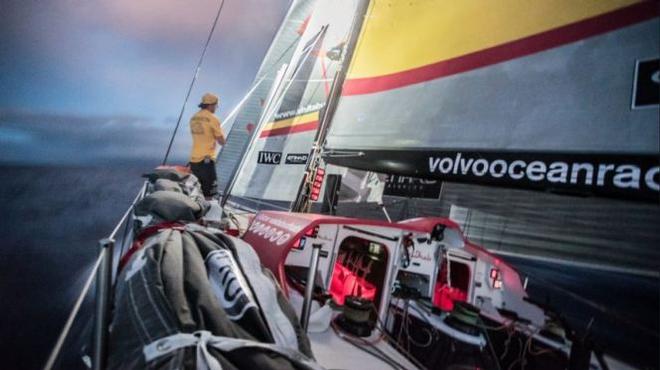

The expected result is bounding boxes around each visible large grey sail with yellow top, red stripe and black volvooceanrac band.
[326,0,660,203]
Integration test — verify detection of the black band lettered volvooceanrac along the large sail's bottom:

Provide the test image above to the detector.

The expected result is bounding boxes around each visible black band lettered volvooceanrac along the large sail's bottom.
[326,149,660,204]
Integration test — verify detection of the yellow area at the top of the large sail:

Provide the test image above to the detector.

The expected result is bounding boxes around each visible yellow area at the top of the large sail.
[348,0,640,79]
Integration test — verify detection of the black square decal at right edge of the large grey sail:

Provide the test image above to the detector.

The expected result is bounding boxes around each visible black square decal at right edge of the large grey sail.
[632,58,660,108]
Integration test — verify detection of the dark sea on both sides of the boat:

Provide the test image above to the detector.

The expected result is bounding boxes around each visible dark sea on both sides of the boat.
[0,163,660,370]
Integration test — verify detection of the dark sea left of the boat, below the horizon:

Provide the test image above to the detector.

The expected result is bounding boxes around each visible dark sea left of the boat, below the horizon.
[0,164,151,369]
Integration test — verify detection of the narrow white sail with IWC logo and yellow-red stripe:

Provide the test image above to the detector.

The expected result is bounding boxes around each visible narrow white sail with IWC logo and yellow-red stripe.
[230,0,358,209]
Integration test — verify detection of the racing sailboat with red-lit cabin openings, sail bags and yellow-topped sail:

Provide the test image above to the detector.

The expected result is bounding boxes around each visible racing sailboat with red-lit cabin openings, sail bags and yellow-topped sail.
[43,0,660,369]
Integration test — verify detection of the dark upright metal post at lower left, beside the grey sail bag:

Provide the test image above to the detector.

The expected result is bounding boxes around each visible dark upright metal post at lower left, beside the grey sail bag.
[92,239,115,370]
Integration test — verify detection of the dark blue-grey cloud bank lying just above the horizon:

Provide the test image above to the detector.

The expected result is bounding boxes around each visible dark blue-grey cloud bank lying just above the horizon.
[0,109,190,164]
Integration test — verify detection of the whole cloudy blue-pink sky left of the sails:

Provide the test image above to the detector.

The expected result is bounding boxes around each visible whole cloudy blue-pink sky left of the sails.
[0,0,289,165]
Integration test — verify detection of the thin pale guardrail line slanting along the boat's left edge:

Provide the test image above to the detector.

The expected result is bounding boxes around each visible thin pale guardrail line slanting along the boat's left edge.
[44,181,147,370]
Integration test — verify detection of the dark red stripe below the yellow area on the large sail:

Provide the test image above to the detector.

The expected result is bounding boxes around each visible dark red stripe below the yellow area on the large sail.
[342,0,659,96]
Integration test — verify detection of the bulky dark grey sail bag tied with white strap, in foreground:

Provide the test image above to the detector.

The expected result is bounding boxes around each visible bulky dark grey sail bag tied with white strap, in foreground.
[108,224,318,369]
